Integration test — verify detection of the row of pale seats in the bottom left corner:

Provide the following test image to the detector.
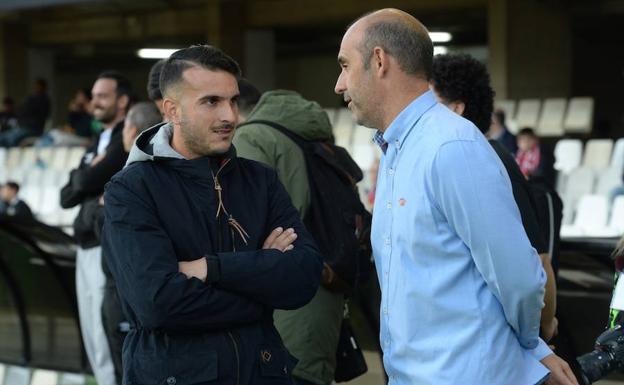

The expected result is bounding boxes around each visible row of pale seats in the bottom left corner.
[0,364,87,385]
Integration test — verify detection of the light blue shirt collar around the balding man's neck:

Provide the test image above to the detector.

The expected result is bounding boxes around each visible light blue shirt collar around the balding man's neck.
[373,90,437,153]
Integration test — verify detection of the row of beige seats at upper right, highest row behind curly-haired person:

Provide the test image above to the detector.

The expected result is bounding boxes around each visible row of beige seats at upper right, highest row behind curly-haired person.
[494,97,594,136]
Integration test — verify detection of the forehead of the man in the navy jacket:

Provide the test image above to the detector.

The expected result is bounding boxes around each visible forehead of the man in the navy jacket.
[182,67,238,97]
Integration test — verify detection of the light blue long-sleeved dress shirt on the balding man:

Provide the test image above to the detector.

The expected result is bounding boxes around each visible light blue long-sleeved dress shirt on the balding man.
[372,92,551,385]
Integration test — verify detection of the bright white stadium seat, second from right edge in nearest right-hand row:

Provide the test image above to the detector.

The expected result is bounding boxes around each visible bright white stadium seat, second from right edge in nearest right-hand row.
[561,195,609,237]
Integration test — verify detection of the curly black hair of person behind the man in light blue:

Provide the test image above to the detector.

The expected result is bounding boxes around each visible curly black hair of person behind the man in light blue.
[432,54,494,132]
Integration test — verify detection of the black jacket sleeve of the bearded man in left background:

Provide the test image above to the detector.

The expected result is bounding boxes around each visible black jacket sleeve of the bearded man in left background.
[61,134,128,208]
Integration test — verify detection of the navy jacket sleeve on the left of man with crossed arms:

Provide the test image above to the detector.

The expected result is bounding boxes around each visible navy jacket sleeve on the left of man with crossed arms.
[102,175,266,331]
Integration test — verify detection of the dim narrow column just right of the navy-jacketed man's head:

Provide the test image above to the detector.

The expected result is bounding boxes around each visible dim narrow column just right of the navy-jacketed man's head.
[243,29,275,92]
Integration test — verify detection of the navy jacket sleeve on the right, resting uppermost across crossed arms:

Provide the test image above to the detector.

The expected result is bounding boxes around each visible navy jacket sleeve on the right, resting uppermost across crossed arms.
[213,170,323,309]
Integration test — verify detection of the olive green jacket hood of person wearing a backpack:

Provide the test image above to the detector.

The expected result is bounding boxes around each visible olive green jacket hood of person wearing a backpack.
[245,90,332,140]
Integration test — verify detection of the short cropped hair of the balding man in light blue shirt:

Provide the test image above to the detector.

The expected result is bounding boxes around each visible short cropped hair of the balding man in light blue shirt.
[358,21,433,80]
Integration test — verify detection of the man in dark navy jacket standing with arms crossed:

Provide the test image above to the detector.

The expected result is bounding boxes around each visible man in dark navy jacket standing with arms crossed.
[103,46,322,385]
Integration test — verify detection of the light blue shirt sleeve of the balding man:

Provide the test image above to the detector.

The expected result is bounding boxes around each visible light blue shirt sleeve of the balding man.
[431,141,546,349]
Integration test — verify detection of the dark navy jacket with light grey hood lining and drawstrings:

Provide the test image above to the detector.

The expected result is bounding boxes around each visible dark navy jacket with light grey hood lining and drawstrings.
[102,125,322,385]
